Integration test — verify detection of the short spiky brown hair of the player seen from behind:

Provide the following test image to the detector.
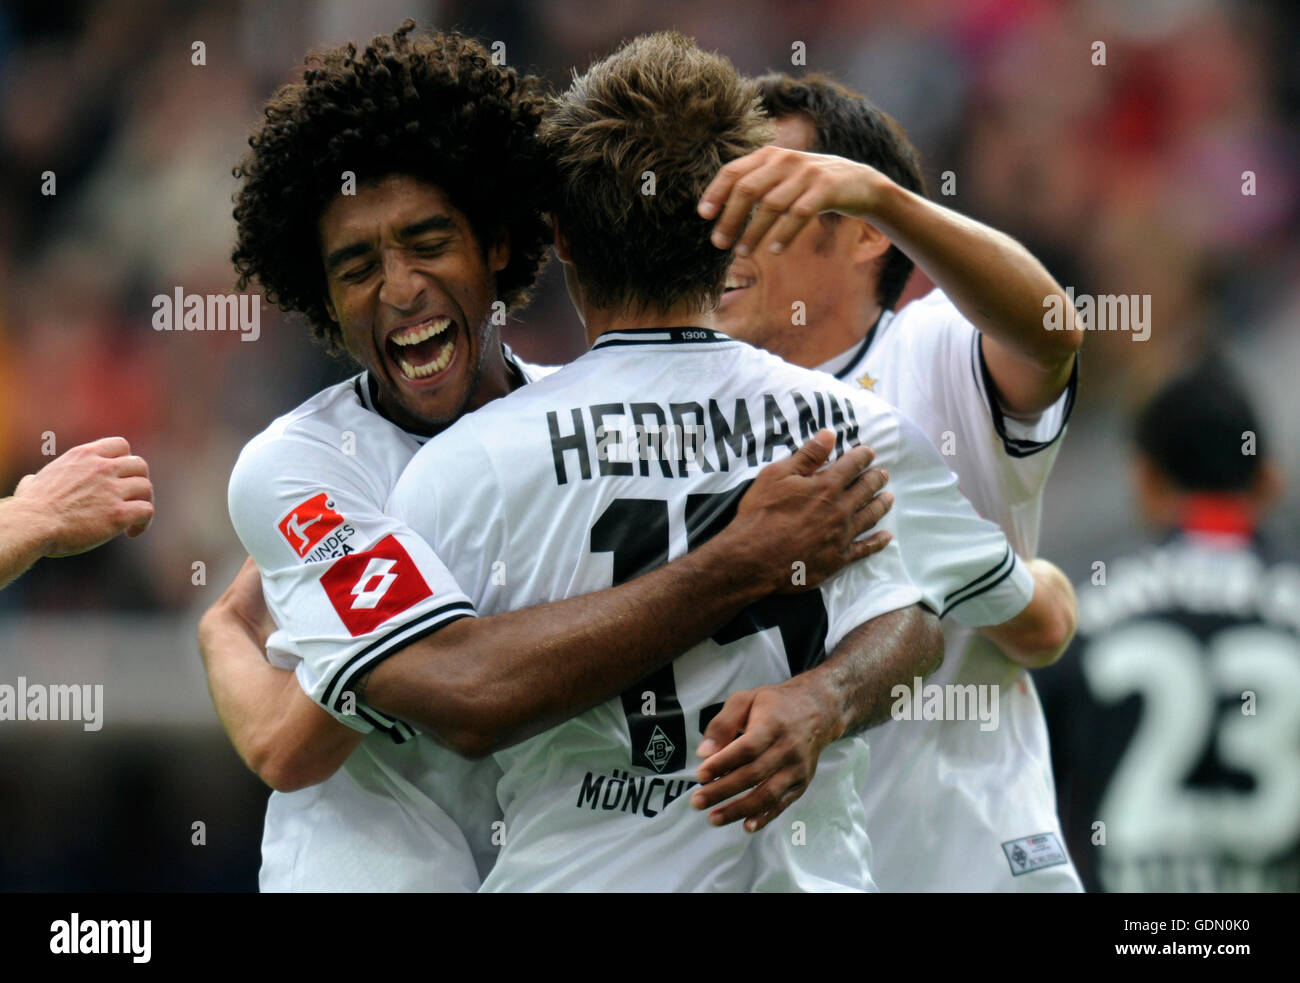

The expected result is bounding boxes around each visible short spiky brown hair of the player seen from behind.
[542,33,774,311]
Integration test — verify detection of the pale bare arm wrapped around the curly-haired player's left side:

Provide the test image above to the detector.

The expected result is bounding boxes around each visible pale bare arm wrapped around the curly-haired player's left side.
[199,560,361,792]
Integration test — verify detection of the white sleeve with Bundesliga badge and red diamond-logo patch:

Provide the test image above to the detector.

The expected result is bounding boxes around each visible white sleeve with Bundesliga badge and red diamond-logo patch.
[229,437,475,741]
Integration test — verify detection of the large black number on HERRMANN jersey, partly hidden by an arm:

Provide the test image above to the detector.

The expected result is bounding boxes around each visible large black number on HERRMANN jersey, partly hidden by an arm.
[592,480,828,772]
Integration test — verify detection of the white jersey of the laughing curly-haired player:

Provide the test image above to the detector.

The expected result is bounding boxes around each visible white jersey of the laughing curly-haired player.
[229,350,546,892]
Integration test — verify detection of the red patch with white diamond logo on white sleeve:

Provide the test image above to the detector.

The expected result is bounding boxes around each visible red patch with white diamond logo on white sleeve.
[321,536,433,637]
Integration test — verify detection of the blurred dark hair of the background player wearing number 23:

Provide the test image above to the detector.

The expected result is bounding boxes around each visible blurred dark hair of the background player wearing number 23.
[1134,356,1265,493]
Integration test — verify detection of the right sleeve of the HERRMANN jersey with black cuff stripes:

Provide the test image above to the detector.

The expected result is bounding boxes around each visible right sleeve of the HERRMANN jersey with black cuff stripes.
[859,407,1034,628]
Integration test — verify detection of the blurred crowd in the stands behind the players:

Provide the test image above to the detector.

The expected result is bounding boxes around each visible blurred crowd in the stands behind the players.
[0,0,1300,889]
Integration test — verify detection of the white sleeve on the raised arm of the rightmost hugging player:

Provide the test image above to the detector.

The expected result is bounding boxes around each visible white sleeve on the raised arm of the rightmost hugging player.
[894,290,1079,510]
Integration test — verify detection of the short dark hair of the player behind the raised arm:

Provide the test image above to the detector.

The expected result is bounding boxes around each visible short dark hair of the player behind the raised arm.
[754,73,926,311]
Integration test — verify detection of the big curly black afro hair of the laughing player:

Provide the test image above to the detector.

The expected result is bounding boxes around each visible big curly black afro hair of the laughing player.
[231,21,554,352]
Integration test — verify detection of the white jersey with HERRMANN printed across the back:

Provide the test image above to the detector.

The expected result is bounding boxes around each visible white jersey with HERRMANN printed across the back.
[389,329,1032,891]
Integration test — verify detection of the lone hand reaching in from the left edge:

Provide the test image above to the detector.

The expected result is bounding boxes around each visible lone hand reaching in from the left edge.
[13,437,153,557]
